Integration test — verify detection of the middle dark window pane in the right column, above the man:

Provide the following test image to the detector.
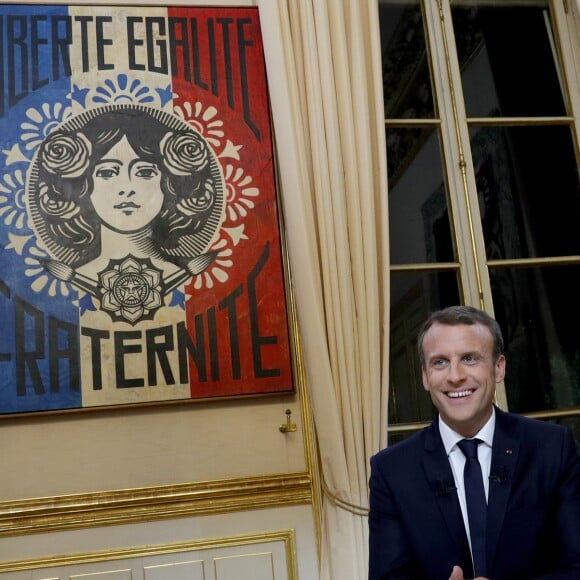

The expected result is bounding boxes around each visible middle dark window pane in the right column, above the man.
[470,125,580,260]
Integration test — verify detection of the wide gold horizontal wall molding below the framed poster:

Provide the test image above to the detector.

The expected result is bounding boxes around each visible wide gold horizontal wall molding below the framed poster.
[0,472,313,538]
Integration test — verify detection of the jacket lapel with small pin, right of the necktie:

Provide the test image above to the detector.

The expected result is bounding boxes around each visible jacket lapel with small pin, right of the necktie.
[487,408,520,563]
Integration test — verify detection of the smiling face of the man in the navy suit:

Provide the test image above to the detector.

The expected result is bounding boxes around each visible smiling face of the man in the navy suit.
[422,323,505,437]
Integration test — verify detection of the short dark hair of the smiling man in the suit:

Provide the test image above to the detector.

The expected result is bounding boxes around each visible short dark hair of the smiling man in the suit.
[417,306,504,368]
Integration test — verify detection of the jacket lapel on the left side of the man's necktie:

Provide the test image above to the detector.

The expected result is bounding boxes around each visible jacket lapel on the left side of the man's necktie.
[423,420,473,575]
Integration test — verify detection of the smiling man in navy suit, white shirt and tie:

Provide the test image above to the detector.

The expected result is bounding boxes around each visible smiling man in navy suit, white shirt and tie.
[369,306,580,580]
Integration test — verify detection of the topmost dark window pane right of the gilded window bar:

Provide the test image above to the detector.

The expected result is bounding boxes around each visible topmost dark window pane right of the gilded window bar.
[452,0,566,117]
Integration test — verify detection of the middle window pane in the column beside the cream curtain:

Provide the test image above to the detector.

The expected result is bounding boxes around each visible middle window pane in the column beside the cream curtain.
[386,128,455,264]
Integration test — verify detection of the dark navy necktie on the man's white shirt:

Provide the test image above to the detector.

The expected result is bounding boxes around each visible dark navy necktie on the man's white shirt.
[457,439,487,576]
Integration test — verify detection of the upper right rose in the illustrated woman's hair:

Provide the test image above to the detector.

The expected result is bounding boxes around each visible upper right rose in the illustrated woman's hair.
[159,132,209,175]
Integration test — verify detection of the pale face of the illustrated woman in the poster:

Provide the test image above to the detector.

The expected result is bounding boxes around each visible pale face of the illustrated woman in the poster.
[91,137,163,233]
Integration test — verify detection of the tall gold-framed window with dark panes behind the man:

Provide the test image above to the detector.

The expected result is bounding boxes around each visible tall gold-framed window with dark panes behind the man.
[379,0,580,442]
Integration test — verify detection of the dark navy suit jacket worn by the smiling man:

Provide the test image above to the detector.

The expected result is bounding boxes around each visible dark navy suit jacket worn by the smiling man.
[369,409,580,580]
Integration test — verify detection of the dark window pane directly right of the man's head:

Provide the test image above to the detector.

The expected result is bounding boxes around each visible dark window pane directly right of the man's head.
[490,265,580,413]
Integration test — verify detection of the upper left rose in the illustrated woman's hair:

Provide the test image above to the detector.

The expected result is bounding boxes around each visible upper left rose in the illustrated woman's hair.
[40,132,92,179]
